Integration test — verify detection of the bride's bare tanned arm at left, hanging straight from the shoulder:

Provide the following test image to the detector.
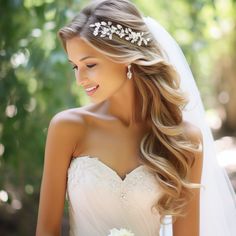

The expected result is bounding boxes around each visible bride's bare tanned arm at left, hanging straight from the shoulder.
[36,110,83,236]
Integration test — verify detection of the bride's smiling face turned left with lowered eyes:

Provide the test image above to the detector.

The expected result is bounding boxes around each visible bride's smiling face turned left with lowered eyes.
[66,37,127,102]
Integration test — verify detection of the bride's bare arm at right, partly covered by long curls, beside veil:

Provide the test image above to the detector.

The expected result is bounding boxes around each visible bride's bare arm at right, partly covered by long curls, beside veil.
[173,122,203,236]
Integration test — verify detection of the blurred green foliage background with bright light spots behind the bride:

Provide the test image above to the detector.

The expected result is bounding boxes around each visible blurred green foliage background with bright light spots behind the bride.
[0,0,236,236]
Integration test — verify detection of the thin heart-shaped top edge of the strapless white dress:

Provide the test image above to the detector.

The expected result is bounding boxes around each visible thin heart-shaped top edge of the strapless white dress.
[71,155,146,183]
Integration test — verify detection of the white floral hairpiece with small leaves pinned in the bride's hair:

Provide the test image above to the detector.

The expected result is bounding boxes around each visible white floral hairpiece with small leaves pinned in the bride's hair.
[89,21,150,46]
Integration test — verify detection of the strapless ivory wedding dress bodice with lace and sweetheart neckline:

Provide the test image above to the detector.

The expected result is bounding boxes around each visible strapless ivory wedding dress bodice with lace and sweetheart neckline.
[66,156,171,236]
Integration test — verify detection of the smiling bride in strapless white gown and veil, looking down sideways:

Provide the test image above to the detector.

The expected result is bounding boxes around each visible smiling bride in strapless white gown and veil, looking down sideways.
[36,0,236,236]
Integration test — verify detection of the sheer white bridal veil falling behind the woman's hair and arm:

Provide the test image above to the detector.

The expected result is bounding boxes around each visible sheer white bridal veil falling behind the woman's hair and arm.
[143,17,236,236]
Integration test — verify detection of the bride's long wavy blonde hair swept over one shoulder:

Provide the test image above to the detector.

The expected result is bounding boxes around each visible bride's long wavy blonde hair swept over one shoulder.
[58,0,203,224]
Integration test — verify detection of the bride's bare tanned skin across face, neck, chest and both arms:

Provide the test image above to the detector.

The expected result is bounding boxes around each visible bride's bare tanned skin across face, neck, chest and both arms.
[36,37,202,236]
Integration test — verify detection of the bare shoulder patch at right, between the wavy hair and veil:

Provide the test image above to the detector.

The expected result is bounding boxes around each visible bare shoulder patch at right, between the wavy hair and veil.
[183,121,203,145]
